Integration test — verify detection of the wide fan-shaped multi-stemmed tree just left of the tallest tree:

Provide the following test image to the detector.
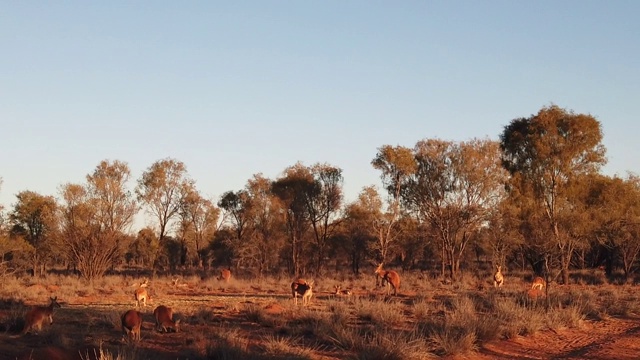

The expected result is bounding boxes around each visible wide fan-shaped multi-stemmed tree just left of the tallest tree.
[403,139,506,279]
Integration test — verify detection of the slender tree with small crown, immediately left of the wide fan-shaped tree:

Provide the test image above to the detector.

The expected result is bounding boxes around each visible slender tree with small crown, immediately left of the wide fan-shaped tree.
[371,145,417,262]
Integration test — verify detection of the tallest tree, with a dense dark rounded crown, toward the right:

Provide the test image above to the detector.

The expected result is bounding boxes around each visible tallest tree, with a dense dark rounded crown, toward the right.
[500,105,606,283]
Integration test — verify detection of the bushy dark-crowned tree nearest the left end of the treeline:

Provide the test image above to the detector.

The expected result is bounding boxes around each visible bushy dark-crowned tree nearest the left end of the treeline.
[9,190,59,276]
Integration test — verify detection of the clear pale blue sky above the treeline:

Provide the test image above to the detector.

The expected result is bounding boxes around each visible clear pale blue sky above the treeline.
[0,0,640,228]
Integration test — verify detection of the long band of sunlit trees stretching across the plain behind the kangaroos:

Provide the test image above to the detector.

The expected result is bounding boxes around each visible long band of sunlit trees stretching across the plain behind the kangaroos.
[0,105,640,284]
